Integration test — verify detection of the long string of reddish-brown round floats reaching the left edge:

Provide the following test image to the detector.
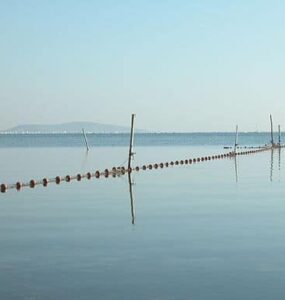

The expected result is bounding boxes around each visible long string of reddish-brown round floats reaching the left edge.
[1,146,272,193]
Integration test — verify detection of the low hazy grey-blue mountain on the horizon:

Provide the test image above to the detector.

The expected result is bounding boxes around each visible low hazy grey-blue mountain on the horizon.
[1,122,146,133]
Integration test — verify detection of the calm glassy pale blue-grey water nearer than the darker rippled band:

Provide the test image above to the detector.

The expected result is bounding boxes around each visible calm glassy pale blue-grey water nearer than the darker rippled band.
[0,137,285,299]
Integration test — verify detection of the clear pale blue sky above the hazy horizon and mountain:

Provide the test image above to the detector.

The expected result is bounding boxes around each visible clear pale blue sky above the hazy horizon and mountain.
[0,0,285,132]
